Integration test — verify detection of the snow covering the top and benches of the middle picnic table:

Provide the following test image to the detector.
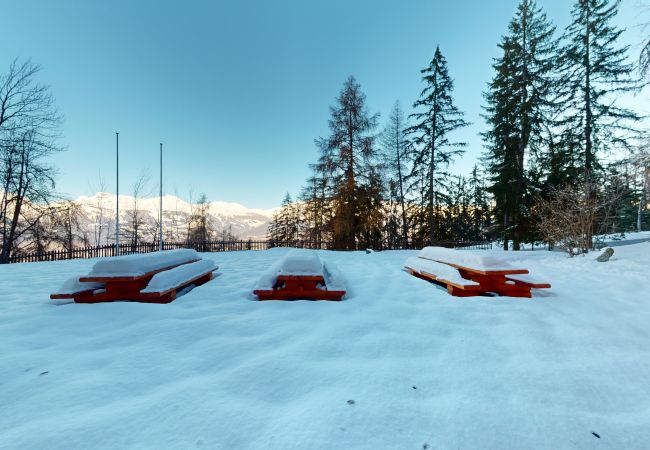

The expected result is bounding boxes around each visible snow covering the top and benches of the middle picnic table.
[254,249,345,291]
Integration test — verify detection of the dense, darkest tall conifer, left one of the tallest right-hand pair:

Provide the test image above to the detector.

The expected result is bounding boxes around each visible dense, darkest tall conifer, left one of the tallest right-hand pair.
[483,0,556,250]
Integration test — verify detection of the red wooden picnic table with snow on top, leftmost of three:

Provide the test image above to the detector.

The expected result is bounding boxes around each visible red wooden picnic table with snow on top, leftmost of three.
[50,249,218,303]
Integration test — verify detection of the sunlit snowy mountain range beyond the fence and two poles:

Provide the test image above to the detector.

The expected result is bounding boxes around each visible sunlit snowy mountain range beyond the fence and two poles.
[74,192,275,241]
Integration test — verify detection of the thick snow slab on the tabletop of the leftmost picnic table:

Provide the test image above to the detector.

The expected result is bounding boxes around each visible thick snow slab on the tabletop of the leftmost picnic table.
[86,248,200,278]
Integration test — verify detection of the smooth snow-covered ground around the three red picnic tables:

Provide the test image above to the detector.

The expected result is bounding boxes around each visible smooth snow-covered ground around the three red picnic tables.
[0,243,650,450]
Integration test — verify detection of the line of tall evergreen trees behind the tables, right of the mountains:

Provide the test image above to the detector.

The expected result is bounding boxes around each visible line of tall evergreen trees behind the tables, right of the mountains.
[268,0,650,252]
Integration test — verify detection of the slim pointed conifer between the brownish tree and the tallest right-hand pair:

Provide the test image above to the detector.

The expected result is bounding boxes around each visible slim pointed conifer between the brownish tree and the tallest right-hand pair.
[406,47,469,242]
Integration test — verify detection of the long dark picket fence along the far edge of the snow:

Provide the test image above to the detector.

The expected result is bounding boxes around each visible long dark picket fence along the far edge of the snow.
[2,240,492,263]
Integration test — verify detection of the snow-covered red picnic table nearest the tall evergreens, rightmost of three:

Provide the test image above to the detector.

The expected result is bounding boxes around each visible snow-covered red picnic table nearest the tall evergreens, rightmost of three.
[404,247,551,298]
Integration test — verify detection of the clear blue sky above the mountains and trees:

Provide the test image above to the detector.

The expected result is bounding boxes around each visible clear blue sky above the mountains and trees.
[0,0,646,208]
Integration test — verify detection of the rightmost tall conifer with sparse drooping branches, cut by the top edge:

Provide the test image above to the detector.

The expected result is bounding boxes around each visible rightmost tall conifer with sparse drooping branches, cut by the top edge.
[560,0,639,180]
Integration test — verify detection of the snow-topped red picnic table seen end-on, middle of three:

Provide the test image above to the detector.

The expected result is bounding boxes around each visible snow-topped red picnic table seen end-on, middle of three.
[253,250,346,300]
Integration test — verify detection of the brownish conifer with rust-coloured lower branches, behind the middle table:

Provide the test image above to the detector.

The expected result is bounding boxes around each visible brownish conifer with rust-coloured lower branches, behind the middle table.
[316,76,378,249]
